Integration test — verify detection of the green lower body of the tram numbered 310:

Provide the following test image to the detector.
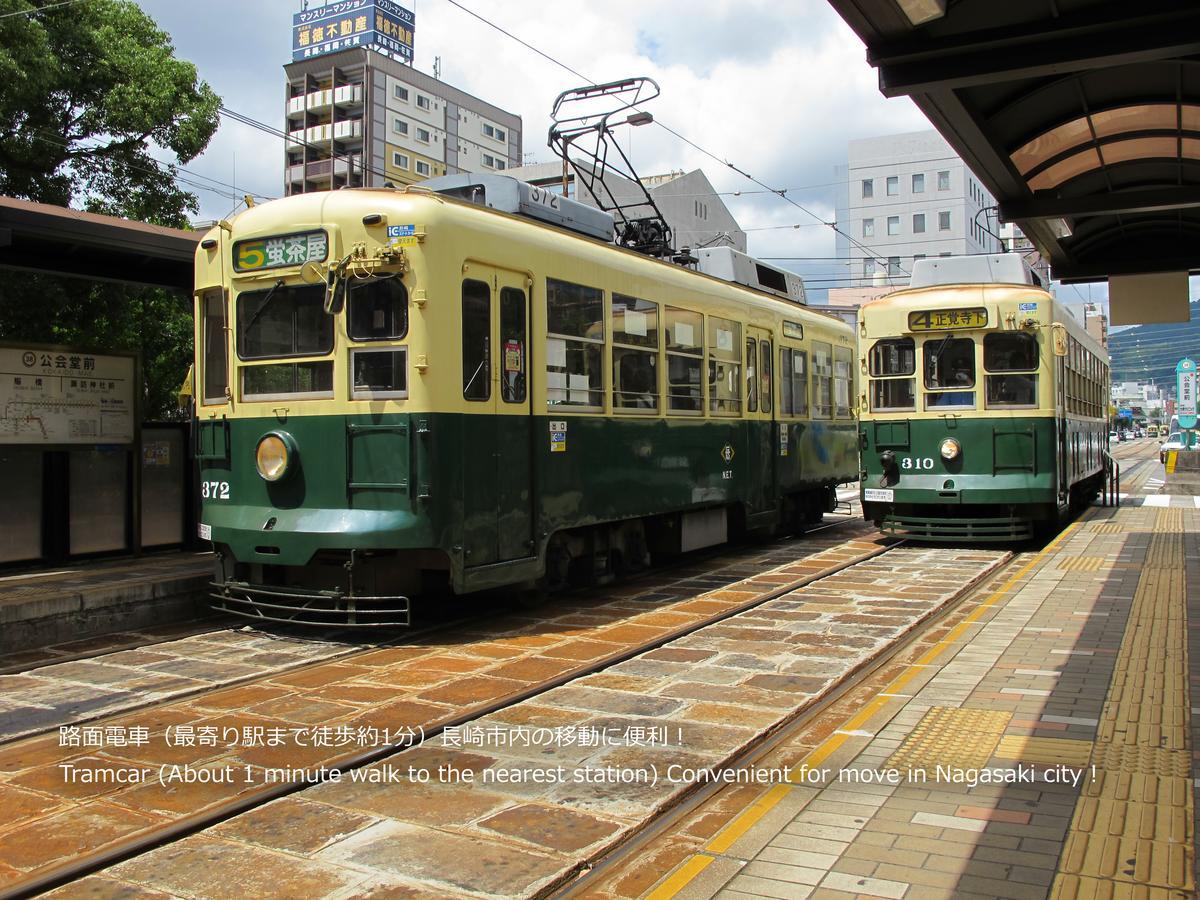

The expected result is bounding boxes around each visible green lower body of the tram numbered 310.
[859,416,1108,542]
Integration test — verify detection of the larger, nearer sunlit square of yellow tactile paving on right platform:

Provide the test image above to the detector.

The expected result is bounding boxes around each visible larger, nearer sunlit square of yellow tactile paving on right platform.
[887,707,1013,770]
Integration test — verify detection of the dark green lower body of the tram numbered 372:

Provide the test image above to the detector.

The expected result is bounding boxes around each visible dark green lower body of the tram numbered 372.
[197,413,858,625]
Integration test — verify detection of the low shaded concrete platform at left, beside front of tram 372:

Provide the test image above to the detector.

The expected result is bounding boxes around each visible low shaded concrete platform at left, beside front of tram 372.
[0,551,212,668]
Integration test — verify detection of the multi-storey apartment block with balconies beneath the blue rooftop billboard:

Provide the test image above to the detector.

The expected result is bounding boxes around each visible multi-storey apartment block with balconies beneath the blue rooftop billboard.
[283,47,521,194]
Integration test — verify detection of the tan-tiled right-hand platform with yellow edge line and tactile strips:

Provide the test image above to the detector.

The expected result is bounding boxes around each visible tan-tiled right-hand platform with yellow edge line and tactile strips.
[624,464,1200,900]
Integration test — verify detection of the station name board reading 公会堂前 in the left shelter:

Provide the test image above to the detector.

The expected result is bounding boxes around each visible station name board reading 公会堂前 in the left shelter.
[0,347,137,446]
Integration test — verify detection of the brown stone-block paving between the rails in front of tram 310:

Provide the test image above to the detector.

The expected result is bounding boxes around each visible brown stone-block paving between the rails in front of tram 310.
[23,540,1007,896]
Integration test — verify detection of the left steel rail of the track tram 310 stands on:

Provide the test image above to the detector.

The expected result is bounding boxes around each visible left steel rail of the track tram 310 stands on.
[0,520,883,900]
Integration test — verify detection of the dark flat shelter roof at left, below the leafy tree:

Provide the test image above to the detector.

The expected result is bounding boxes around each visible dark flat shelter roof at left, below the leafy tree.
[0,197,202,293]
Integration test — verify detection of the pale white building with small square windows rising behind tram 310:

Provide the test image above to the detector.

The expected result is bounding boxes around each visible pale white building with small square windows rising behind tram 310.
[830,130,1002,286]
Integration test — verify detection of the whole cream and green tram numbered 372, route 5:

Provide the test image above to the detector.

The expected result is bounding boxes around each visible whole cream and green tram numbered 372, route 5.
[196,176,858,625]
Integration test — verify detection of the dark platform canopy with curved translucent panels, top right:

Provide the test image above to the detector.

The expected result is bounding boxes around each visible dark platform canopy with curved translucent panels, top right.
[829,0,1200,296]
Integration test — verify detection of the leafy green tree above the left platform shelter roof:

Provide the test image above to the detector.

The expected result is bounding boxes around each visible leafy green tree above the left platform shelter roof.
[0,0,221,228]
